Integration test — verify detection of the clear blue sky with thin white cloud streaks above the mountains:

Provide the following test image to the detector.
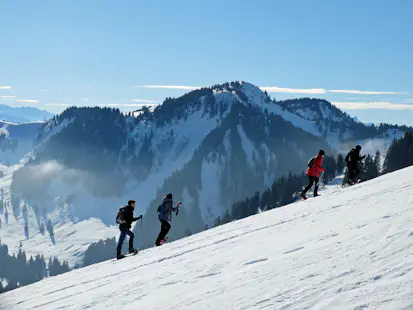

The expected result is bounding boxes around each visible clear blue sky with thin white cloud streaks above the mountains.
[0,0,413,125]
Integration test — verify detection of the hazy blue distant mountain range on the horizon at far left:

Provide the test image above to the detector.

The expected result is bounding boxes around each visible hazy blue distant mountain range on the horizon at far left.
[0,104,54,124]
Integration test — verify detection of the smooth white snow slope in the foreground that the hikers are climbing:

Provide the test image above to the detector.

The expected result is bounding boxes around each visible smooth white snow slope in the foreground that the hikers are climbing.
[0,167,413,310]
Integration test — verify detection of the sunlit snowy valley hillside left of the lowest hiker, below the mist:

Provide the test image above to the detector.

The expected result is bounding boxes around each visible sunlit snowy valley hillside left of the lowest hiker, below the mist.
[0,165,119,268]
